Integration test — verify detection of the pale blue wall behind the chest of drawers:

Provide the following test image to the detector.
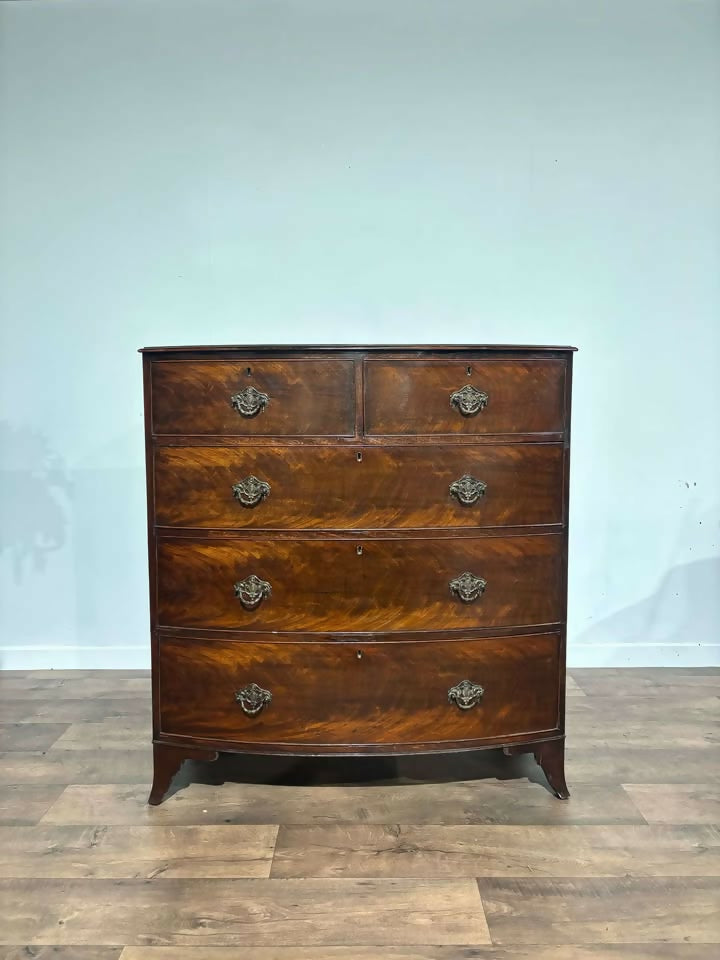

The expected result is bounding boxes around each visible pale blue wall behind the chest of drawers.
[0,0,720,667]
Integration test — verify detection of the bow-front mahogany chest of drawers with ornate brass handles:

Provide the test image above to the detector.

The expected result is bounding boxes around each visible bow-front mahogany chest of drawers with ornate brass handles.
[142,346,573,804]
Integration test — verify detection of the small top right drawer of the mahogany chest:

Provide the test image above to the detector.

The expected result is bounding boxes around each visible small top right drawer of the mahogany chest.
[365,360,565,436]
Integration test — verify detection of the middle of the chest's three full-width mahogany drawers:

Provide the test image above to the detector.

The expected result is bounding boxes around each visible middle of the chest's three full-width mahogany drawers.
[157,534,563,633]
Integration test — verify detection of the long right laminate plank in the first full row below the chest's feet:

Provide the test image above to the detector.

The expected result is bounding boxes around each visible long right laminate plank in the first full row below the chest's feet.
[271,824,720,877]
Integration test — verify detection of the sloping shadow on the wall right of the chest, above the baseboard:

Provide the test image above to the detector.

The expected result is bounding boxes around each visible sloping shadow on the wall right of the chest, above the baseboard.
[572,557,720,653]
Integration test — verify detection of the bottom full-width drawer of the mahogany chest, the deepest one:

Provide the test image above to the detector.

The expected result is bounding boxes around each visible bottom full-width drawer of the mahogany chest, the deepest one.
[159,634,560,747]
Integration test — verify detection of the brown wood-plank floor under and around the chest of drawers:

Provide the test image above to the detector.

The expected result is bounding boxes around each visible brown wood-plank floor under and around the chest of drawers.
[0,669,720,960]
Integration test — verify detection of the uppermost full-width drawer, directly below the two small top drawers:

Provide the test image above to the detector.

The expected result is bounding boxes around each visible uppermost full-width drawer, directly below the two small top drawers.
[155,443,563,530]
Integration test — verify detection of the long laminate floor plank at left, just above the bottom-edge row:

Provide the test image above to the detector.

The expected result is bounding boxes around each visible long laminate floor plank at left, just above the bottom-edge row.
[0,878,490,947]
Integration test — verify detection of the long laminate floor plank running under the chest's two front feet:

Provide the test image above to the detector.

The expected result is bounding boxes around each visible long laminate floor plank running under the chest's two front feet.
[42,780,645,825]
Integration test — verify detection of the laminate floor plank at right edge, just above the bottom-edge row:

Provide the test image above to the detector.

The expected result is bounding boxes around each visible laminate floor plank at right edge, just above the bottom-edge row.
[478,877,720,950]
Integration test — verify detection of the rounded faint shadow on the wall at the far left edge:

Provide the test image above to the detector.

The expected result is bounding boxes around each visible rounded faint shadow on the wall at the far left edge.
[0,421,72,583]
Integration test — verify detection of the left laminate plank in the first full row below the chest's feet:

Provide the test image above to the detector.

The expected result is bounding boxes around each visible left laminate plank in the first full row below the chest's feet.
[0,824,278,879]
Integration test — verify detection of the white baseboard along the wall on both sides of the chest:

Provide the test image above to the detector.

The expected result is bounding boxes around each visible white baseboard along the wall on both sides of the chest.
[0,643,720,670]
